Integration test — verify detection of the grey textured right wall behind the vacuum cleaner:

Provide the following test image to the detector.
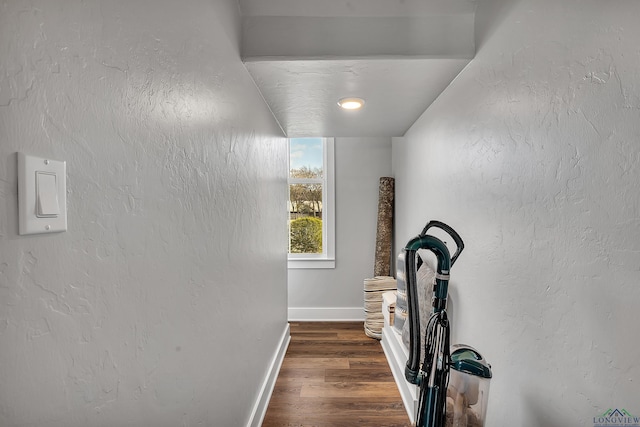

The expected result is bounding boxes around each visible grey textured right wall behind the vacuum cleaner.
[393,0,640,426]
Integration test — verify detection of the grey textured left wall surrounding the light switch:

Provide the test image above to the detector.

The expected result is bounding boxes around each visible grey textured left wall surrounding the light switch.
[0,0,287,427]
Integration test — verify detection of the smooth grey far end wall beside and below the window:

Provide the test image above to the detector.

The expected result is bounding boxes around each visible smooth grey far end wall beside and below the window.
[289,138,391,319]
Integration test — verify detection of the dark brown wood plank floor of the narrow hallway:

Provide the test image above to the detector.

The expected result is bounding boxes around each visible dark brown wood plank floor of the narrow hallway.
[262,322,411,427]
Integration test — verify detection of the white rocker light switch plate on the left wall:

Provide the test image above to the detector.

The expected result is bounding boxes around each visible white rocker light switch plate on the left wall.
[18,153,67,235]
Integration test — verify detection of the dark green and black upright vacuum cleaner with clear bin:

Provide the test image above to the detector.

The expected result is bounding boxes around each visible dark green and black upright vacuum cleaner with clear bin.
[398,221,492,427]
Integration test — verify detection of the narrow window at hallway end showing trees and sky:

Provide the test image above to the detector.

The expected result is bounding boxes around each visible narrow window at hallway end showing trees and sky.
[288,138,335,268]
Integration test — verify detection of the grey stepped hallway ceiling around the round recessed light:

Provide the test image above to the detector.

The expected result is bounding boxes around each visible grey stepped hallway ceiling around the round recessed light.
[239,0,475,137]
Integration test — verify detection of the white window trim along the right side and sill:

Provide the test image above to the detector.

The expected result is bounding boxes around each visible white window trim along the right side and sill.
[287,138,336,269]
